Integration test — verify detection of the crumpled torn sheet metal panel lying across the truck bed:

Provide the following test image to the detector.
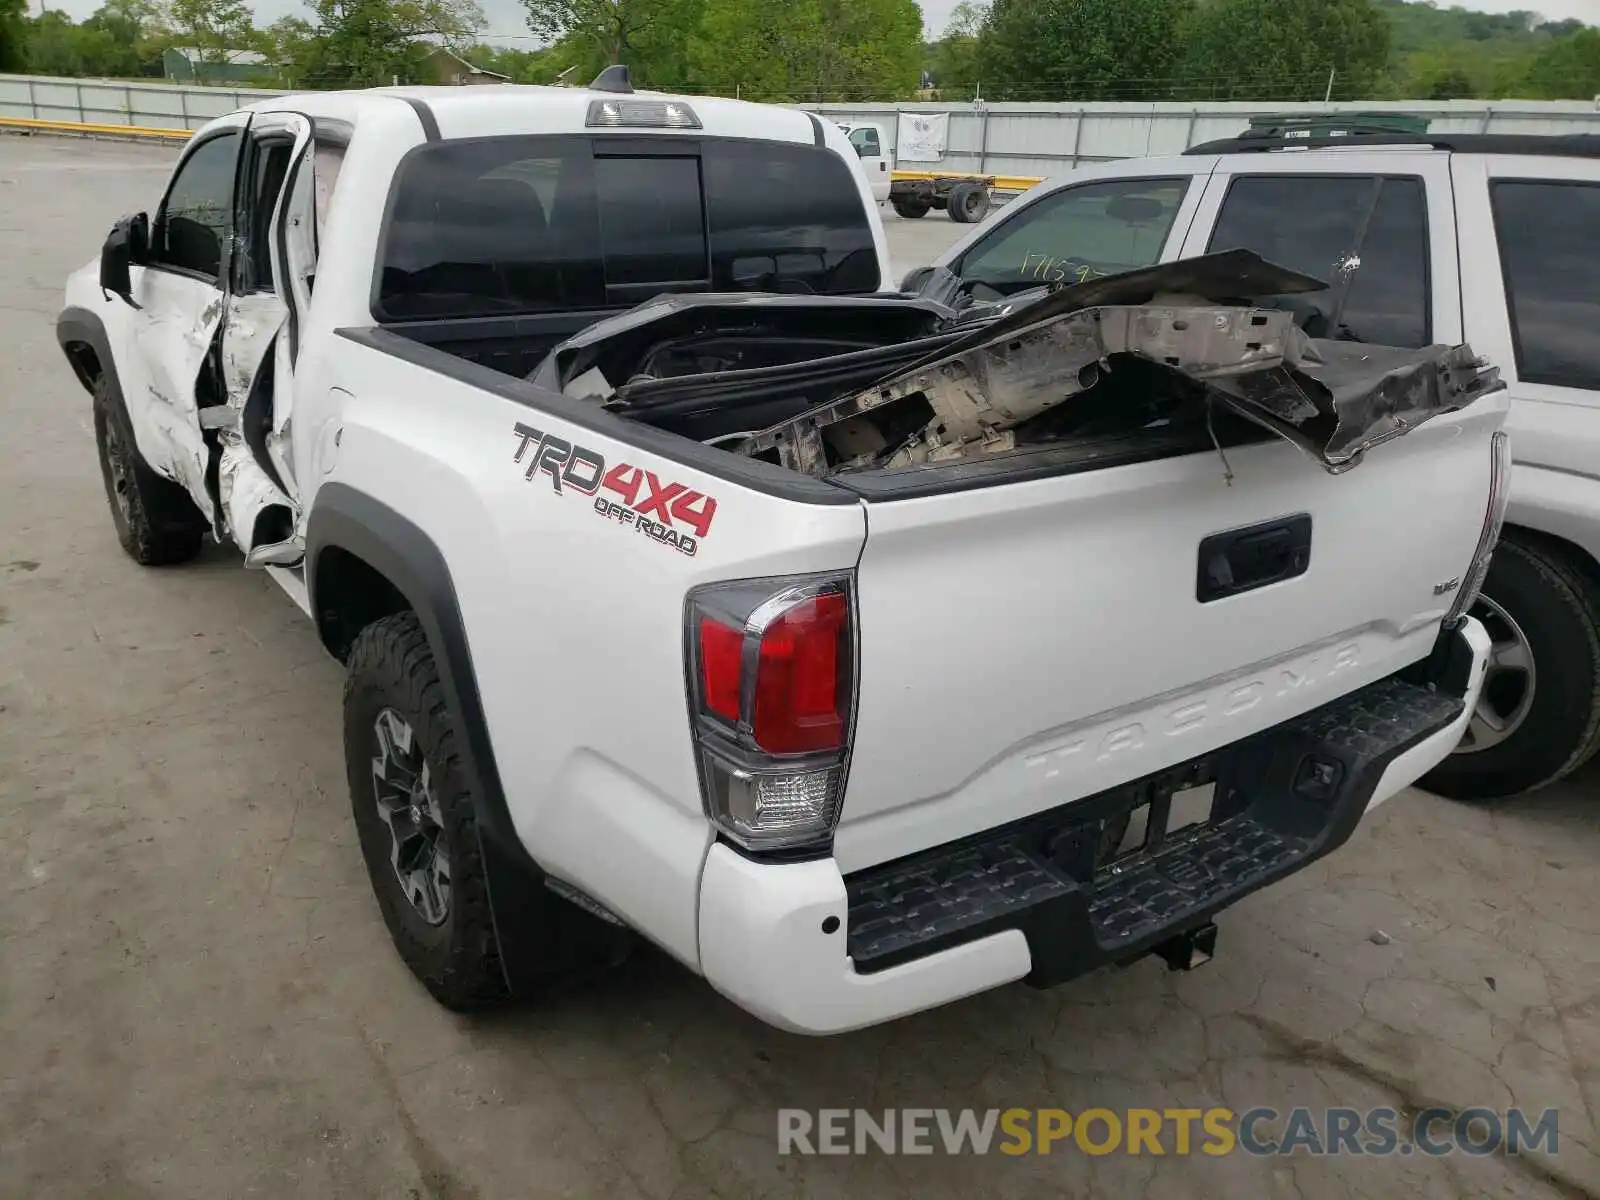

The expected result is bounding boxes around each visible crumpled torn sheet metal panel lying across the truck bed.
[742,251,1504,475]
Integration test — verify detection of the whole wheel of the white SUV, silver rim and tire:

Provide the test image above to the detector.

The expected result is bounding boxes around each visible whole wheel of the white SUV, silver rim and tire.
[1421,534,1600,800]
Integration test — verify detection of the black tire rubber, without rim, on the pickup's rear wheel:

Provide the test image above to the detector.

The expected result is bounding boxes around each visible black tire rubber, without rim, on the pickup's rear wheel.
[344,613,510,1011]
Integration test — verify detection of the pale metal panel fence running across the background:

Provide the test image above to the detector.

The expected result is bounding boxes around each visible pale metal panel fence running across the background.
[0,75,1600,176]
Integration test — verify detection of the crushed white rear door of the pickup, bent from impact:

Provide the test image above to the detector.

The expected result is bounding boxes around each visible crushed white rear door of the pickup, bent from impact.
[219,112,317,566]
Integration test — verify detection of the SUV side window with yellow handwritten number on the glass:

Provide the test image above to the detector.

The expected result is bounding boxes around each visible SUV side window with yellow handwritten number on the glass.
[955,176,1189,294]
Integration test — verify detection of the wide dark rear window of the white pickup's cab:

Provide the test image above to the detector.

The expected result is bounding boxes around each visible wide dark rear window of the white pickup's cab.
[376,138,882,320]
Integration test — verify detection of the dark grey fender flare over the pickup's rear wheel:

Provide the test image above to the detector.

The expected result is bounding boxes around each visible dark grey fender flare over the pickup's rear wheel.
[306,483,627,995]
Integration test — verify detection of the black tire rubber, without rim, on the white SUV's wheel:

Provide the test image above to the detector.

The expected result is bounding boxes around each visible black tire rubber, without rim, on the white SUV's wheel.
[1419,533,1600,800]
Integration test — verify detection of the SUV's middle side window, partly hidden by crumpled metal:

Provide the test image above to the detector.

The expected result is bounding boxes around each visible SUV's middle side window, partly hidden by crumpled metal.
[1211,174,1430,347]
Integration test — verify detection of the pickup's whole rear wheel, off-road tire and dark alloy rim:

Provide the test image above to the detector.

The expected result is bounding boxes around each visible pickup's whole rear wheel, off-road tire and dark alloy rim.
[344,613,510,1011]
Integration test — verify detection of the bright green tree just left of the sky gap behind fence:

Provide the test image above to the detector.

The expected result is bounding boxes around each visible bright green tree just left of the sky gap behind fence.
[690,0,923,102]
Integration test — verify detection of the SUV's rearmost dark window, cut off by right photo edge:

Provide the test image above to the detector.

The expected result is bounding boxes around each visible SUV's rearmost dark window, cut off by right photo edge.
[1491,182,1600,387]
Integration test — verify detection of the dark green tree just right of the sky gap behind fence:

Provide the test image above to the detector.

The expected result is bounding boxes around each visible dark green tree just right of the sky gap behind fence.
[979,0,1190,101]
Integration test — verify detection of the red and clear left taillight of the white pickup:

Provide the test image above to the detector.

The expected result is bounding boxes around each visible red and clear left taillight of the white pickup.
[686,574,856,850]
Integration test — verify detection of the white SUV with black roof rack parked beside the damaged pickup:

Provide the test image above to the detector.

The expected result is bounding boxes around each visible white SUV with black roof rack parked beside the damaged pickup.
[906,130,1600,800]
